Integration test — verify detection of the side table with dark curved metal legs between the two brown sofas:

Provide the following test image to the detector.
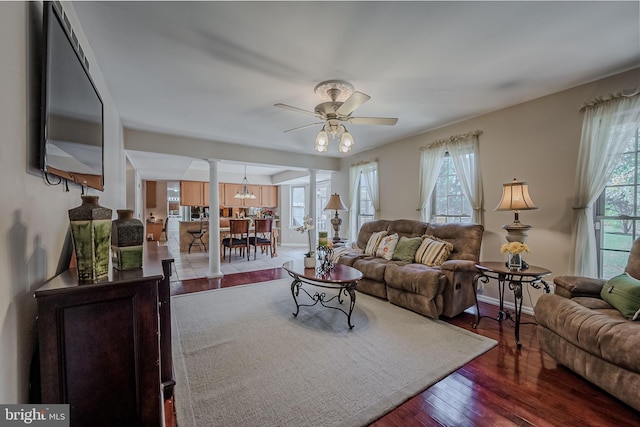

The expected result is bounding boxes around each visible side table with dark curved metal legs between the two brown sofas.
[471,262,551,348]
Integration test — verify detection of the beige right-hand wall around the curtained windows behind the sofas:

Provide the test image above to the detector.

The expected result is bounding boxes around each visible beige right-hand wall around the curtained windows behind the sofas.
[341,69,640,307]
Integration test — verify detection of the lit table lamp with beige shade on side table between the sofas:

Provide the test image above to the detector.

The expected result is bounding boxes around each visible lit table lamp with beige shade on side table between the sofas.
[494,178,538,243]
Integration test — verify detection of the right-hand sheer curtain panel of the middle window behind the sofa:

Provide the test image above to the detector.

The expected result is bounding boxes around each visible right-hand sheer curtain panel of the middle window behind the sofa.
[447,133,484,225]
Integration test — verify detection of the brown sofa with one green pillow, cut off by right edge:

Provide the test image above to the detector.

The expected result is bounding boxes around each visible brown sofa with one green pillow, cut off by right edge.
[535,239,640,410]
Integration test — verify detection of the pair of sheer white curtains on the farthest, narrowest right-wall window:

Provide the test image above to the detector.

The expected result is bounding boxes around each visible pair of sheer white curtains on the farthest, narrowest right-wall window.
[349,161,380,240]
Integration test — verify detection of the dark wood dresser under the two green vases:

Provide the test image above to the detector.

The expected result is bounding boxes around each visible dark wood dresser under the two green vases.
[35,242,175,426]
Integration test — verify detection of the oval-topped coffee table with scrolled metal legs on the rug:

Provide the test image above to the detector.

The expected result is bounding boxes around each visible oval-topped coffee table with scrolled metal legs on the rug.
[282,260,362,329]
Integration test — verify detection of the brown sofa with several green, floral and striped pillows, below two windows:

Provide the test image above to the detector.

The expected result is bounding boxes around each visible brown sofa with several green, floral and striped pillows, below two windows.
[338,219,484,318]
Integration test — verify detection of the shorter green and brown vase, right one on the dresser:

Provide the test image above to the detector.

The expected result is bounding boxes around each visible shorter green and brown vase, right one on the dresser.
[111,209,144,270]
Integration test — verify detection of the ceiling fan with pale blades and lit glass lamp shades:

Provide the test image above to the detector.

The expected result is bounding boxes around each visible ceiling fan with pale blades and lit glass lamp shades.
[274,80,398,152]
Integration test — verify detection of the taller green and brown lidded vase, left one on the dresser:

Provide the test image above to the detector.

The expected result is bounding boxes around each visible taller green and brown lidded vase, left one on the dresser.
[69,196,111,282]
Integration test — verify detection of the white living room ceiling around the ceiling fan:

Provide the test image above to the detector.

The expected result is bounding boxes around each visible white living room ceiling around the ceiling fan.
[73,1,640,177]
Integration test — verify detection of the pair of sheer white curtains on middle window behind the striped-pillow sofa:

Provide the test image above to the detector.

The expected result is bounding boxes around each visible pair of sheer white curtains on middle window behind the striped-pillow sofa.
[419,131,484,224]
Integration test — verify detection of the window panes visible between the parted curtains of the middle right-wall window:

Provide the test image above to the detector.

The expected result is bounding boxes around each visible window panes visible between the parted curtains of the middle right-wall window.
[431,153,473,223]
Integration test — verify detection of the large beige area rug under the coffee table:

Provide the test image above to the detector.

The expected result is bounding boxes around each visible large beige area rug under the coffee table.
[171,279,496,427]
